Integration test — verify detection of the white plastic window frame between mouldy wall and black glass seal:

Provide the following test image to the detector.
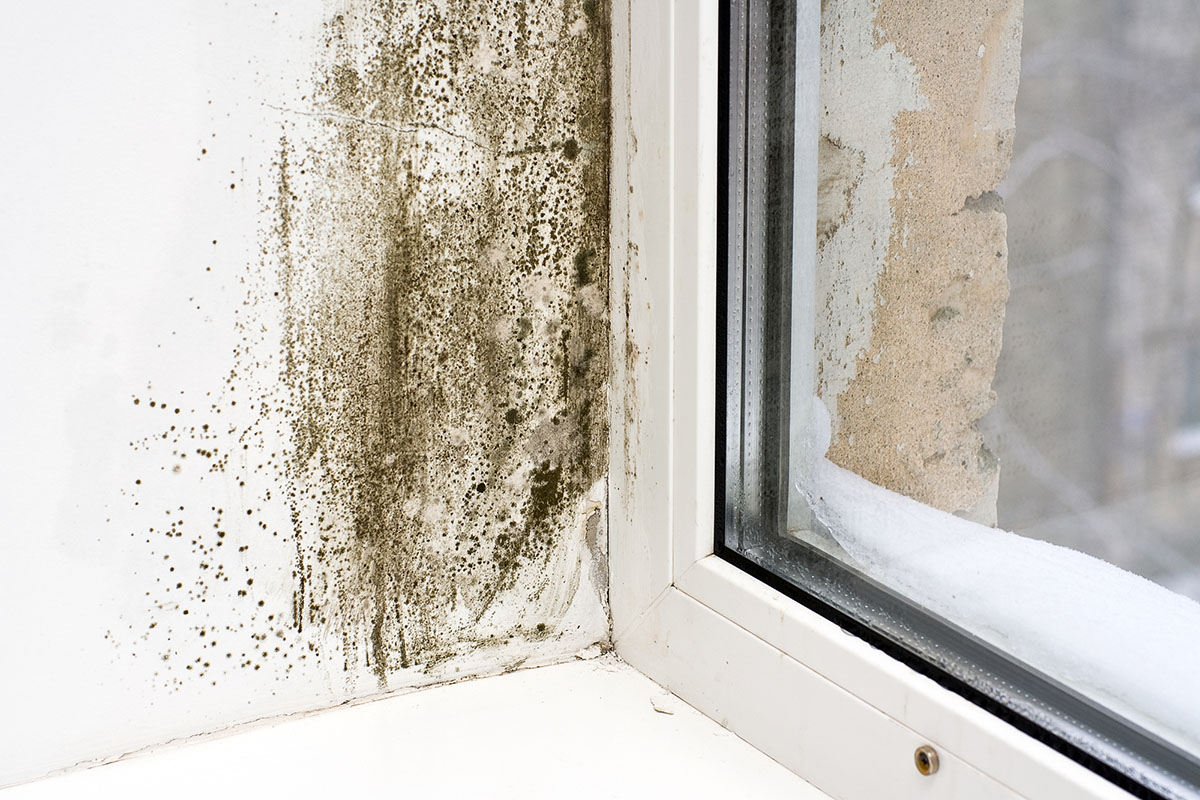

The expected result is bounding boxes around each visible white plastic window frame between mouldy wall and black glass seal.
[608,0,1130,800]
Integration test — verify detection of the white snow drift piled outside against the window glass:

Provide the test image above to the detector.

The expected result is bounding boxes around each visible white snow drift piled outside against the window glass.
[797,399,1200,752]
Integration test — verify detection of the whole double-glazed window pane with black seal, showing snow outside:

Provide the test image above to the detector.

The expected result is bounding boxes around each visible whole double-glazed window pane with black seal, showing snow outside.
[718,0,1200,796]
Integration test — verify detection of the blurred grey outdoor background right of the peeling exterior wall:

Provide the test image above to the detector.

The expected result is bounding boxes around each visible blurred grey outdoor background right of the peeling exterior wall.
[986,0,1200,600]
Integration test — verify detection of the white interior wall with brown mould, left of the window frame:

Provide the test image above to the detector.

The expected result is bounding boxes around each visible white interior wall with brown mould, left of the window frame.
[0,0,608,786]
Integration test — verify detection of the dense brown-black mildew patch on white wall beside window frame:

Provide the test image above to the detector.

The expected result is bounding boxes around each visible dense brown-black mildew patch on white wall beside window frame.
[275,2,608,681]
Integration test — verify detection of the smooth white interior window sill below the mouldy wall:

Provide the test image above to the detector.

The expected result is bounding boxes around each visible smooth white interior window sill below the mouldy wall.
[0,656,827,800]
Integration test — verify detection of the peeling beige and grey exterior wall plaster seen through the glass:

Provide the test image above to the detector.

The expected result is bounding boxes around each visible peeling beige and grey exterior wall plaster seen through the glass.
[817,0,1022,524]
